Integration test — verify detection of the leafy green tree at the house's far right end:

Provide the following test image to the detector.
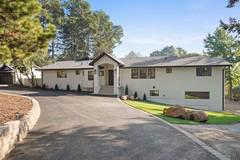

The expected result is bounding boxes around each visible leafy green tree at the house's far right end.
[204,27,240,99]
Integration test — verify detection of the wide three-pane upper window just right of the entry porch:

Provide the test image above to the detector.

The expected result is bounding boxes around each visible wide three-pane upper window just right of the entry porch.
[131,68,155,79]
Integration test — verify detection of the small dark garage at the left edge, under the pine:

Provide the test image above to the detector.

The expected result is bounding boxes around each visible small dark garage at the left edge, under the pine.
[0,65,14,84]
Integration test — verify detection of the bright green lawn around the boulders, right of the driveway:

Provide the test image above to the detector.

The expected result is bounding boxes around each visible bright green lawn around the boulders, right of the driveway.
[123,100,240,124]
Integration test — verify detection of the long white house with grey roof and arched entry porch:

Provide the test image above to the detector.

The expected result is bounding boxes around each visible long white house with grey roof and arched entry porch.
[40,53,230,111]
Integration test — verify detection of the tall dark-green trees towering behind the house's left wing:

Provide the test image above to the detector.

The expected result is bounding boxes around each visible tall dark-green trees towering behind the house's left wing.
[60,0,123,60]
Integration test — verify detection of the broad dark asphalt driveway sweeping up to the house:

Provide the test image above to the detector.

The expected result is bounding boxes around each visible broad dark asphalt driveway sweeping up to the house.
[0,88,217,160]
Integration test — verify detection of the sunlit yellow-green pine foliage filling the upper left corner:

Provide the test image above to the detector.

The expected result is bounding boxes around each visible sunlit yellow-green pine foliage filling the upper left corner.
[0,0,55,83]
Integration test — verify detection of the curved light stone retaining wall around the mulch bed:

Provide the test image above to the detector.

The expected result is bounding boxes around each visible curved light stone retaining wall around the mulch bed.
[0,93,41,160]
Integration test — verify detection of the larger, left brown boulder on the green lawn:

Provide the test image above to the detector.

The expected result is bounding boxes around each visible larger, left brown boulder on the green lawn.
[163,105,187,119]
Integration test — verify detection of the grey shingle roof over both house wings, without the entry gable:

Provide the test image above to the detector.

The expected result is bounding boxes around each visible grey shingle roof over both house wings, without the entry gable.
[40,55,231,70]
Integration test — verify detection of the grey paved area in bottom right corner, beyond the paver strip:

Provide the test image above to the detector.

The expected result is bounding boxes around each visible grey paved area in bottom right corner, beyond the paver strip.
[178,123,240,160]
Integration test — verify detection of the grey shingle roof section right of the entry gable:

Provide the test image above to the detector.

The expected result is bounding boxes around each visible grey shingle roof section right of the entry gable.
[121,55,230,67]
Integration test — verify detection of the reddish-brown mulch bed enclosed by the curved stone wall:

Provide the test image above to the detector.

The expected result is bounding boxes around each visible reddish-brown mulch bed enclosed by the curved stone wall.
[0,93,32,124]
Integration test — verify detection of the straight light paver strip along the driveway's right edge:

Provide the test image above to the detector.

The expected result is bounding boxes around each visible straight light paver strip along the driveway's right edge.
[117,98,230,160]
